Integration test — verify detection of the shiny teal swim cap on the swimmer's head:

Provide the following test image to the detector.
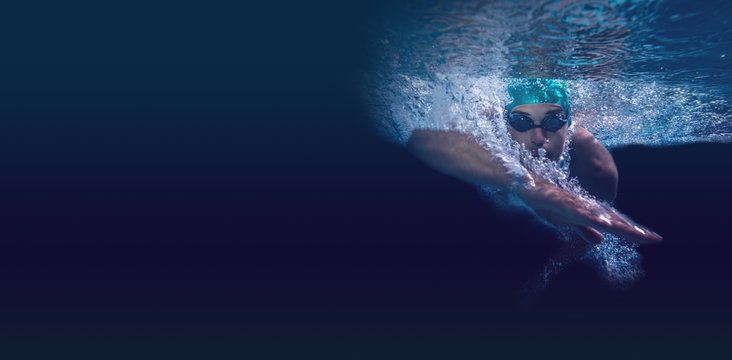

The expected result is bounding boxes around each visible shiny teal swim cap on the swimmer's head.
[506,78,572,125]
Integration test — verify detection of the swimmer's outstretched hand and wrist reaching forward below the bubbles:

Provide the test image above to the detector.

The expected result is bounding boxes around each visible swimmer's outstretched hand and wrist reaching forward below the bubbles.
[516,176,663,244]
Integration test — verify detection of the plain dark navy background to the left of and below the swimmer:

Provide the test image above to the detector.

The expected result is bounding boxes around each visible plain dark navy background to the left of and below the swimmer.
[0,3,732,359]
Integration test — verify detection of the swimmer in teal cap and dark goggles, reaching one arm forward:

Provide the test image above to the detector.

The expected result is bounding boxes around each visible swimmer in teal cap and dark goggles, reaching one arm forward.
[407,79,662,244]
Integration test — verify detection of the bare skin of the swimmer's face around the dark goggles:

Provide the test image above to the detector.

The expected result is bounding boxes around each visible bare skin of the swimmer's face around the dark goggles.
[508,103,567,161]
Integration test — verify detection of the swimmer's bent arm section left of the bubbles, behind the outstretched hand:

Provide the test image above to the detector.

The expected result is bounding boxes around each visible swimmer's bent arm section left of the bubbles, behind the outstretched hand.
[407,130,515,190]
